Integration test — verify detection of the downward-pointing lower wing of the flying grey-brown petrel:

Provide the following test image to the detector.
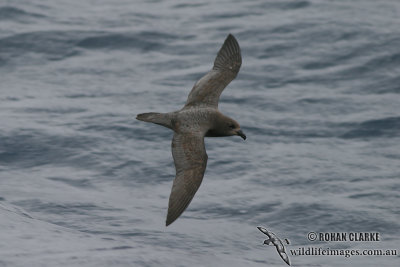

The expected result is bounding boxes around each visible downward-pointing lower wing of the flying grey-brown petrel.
[166,132,208,226]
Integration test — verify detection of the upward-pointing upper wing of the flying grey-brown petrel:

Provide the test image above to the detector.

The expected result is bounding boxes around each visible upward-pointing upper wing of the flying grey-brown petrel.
[184,34,242,108]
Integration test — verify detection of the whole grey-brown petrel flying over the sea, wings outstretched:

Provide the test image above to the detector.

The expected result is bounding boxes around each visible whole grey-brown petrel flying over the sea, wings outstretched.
[136,34,246,226]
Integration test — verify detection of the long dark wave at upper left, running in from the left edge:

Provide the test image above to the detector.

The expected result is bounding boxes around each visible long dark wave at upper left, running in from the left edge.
[0,31,178,66]
